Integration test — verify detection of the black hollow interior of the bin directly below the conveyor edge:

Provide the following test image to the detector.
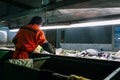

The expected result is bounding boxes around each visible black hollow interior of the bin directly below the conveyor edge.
[34,54,120,80]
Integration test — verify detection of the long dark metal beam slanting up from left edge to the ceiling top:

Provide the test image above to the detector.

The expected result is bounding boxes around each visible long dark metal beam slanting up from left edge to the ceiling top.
[0,0,90,21]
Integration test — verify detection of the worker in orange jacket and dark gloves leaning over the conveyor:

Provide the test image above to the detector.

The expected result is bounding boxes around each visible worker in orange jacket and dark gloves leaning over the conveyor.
[12,16,55,59]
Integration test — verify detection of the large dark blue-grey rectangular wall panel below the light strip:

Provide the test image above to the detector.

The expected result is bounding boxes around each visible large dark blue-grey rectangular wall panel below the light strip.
[64,26,112,43]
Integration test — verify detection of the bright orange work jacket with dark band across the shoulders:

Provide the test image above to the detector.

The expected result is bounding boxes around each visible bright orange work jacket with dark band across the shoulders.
[13,24,47,59]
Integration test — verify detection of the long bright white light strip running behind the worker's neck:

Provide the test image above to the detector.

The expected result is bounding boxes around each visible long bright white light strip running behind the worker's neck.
[10,19,120,32]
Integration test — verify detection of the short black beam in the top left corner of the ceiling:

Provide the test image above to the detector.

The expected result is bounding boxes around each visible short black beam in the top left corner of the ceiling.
[0,0,33,9]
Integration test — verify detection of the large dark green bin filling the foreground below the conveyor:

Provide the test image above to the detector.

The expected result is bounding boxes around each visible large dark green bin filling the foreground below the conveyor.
[0,51,120,80]
